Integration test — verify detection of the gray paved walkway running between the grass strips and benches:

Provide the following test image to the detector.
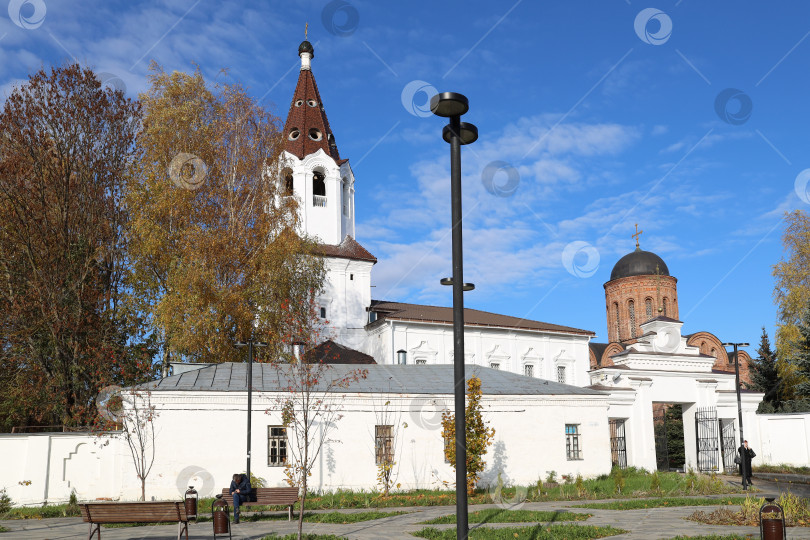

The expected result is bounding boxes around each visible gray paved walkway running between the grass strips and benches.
[6,477,810,540]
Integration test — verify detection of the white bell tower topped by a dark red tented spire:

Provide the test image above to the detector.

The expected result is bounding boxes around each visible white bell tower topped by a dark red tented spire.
[280,41,377,349]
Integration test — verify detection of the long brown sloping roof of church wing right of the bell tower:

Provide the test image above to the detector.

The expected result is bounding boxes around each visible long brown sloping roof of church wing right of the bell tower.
[369,300,596,336]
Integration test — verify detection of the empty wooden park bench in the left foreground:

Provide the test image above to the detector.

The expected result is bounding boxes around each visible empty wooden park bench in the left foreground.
[79,501,188,540]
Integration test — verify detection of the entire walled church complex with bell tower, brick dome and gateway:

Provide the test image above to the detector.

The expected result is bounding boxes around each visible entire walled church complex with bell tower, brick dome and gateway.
[0,41,810,504]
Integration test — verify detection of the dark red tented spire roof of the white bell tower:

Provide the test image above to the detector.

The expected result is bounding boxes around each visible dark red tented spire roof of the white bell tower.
[284,60,346,160]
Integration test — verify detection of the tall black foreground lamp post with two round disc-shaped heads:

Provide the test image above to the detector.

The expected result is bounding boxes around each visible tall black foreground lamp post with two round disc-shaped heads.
[430,92,478,540]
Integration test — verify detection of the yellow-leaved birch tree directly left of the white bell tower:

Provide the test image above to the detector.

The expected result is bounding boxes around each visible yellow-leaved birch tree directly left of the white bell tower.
[125,64,324,373]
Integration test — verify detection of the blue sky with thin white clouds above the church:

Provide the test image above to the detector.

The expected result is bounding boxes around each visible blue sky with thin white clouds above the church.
[0,0,810,349]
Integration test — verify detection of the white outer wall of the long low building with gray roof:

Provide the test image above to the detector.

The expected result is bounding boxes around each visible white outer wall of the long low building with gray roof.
[60,392,610,500]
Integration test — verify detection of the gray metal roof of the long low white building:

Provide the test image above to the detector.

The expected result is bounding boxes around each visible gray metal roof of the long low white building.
[140,363,604,396]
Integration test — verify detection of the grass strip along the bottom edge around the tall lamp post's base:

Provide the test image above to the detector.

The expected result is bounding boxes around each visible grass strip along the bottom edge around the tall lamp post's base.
[412,525,627,540]
